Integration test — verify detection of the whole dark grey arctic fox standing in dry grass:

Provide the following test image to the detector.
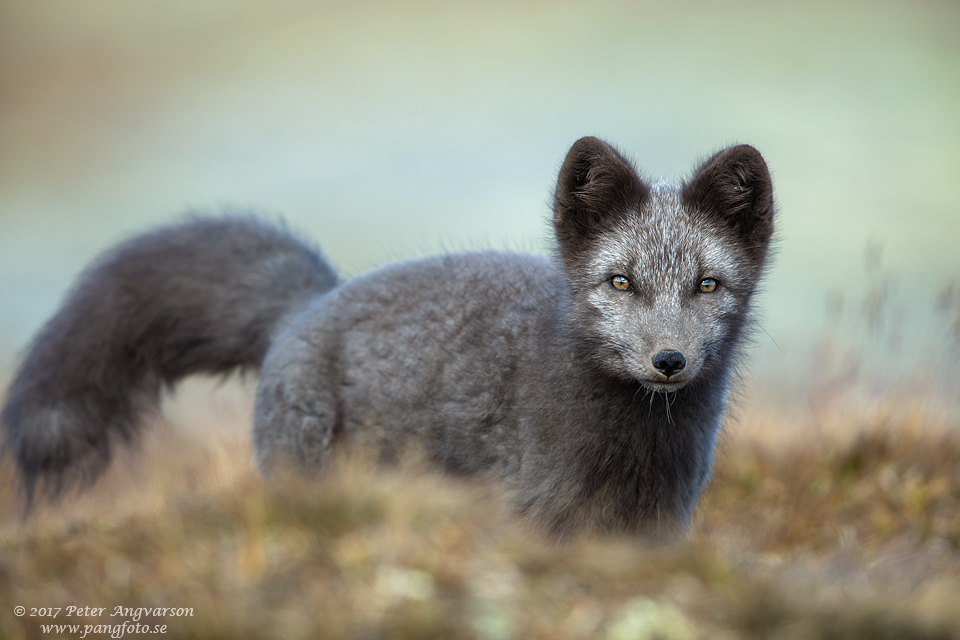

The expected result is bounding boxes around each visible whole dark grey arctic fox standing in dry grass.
[0,137,774,538]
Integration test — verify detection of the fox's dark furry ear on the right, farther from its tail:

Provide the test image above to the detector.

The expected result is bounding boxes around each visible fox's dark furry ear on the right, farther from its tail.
[681,144,774,255]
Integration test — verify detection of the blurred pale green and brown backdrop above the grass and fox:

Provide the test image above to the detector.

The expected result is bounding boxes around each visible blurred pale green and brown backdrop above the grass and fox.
[0,0,960,384]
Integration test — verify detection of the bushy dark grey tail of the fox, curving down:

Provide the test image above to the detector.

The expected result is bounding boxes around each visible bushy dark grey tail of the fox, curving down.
[0,217,337,508]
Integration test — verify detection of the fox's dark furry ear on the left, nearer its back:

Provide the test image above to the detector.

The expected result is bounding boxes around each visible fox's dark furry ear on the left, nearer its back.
[553,136,650,246]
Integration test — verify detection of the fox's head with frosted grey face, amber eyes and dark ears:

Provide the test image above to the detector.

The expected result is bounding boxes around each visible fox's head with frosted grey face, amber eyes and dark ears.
[553,137,774,392]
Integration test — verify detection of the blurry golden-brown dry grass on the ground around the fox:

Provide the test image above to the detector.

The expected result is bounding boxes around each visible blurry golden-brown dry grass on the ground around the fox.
[0,376,960,639]
